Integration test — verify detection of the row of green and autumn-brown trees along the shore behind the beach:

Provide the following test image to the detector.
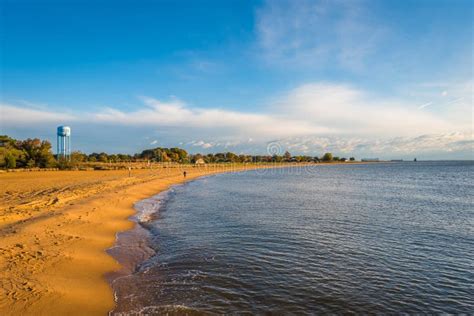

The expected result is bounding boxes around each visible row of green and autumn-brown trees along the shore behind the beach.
[0,135,355,169]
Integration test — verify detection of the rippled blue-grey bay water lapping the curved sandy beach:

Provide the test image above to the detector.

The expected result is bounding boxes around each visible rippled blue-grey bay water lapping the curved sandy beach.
[110,162,474,315]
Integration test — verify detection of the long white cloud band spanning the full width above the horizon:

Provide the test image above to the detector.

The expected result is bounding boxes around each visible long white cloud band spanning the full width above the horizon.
[1,83,473,154]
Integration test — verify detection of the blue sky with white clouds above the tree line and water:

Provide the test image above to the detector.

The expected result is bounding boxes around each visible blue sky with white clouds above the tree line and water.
[0,0,474,159]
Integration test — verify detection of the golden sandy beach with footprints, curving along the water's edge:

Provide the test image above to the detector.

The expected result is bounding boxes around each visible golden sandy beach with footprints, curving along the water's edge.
[0,165,284,315]
